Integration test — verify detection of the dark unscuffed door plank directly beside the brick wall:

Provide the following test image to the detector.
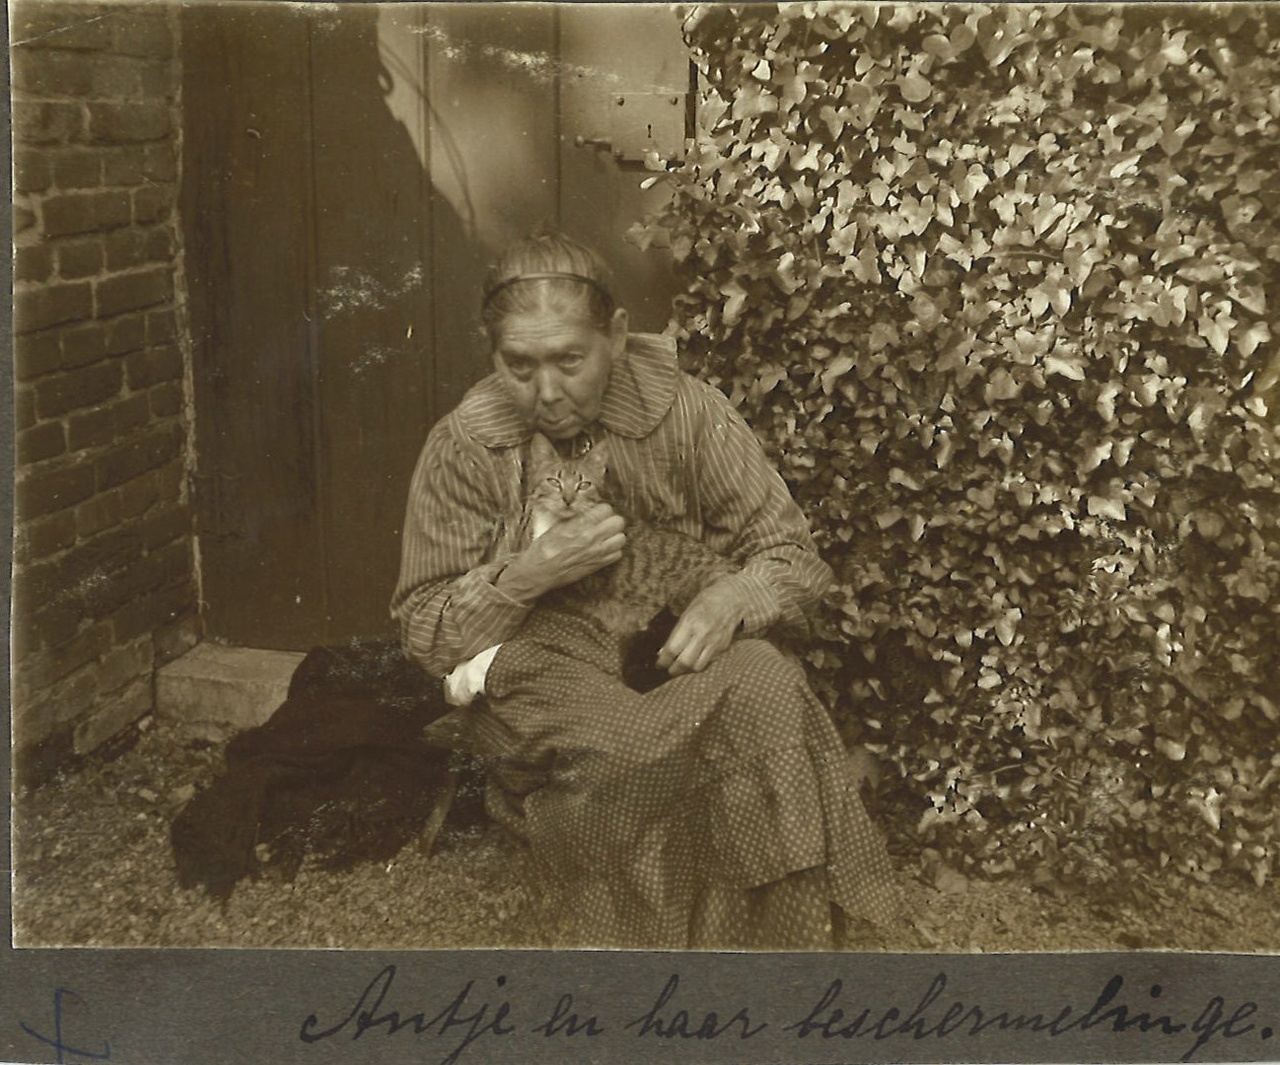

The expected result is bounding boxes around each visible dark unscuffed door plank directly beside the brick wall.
[182,4,323,648]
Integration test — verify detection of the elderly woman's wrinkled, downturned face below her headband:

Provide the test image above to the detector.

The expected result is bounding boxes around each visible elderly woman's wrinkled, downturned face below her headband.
[493,307,627,440]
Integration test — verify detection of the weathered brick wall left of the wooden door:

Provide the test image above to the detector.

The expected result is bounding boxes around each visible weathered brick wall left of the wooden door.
[10,0,197,776]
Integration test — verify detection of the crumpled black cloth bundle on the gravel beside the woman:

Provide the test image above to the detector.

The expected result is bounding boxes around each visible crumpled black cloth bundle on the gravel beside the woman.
[170,640,481,899]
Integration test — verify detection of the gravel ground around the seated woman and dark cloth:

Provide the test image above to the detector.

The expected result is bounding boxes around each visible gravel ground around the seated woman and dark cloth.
[13,721,1280,952]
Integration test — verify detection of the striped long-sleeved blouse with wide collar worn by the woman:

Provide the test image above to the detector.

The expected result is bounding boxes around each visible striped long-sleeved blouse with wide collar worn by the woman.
[392,334,831,676]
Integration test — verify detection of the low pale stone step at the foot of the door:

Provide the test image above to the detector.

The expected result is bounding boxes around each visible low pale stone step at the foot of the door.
[156,643,303,731]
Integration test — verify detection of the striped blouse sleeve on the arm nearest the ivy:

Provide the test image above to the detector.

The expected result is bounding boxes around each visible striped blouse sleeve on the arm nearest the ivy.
[694,385,832,635]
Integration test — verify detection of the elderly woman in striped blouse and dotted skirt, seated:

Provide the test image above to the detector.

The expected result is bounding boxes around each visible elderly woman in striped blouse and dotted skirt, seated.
[392,236,897,950]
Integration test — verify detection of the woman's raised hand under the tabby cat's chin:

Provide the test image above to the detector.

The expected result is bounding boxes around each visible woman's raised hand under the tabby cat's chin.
[497,503,627,603]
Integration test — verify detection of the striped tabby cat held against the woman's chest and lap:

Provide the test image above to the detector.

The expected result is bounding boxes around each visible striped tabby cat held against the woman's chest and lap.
[445,434,739,705]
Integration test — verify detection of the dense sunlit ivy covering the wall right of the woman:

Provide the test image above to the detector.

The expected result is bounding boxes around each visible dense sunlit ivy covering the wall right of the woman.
[634,4,1280,883]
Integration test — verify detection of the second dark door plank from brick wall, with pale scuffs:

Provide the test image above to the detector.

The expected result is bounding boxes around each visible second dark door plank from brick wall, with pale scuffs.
[310,4,433,643]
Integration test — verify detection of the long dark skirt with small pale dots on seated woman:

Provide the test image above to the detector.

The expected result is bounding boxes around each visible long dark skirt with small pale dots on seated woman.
[475,612,899,950]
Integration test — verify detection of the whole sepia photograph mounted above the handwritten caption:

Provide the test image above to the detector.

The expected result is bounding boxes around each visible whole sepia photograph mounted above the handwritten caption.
[9,0,1280,967]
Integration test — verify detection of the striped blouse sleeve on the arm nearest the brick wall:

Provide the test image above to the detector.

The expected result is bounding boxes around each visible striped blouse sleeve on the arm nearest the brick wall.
[392,417,530,676]
